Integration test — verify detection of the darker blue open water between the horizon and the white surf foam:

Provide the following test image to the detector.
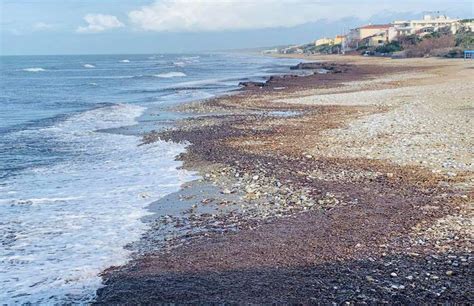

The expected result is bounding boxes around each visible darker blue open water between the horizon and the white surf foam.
[0,54,294,178]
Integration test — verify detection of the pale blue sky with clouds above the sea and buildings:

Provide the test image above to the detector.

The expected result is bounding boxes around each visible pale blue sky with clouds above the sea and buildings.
[0,0,474,55]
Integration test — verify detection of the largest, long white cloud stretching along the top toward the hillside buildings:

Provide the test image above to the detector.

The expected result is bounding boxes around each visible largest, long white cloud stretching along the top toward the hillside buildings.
[128,0,436,32]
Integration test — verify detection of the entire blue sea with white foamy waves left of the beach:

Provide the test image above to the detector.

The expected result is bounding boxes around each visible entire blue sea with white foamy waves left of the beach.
[0,53,302,304]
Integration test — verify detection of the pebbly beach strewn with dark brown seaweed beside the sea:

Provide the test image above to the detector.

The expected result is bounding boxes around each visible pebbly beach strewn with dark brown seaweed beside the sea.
[96,56,474,304]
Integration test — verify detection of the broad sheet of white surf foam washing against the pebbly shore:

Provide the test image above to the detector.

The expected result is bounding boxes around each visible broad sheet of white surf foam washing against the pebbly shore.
[0,105,195,304]
